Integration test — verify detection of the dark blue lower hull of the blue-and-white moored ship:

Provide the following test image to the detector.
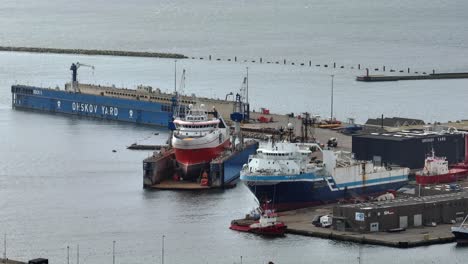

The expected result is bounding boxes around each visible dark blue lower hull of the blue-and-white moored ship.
[241,176,407,211]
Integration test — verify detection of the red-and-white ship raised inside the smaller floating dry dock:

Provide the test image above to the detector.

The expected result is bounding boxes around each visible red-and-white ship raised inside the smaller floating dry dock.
[172,104,231,180]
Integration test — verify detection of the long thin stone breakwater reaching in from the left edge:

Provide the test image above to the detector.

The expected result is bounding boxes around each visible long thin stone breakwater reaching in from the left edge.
[0,46,188,59]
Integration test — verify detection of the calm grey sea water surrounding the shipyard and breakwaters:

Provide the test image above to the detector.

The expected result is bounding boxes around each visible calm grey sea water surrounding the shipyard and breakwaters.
[0,0,468,263]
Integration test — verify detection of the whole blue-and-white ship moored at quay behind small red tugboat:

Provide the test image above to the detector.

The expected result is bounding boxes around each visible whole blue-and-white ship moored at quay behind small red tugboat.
[240,142,409,211]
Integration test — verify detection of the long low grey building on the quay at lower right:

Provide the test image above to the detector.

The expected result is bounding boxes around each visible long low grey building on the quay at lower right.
[333,192,468,233]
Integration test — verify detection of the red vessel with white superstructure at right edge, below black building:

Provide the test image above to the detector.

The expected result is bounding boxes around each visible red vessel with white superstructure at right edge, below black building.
[416,150,467,185]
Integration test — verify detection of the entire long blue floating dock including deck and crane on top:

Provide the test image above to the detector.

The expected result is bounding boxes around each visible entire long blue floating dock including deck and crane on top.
[11,63,248,127]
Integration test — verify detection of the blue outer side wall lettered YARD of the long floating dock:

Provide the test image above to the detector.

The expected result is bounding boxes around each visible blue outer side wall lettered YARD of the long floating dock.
[11,85,172,127]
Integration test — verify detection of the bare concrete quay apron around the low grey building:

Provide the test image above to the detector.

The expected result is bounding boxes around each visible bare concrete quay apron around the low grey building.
[279,205,455,248]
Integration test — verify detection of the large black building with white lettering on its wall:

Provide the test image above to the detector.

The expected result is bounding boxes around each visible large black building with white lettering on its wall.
[352,130,465,169]
